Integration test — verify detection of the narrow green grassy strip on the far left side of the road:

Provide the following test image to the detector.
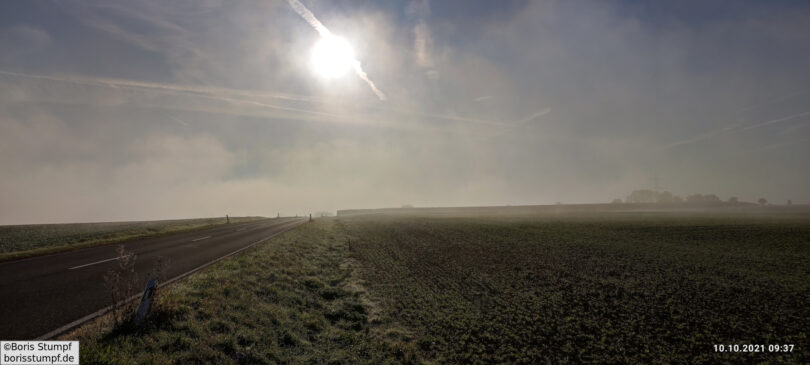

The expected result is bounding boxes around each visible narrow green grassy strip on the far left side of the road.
[0,217,266,262]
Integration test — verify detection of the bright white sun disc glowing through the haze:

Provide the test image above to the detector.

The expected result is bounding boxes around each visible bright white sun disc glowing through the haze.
[310,35,357,79]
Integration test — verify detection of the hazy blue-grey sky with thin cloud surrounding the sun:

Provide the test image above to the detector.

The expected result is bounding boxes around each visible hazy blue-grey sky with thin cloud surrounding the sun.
[0,0,810,224]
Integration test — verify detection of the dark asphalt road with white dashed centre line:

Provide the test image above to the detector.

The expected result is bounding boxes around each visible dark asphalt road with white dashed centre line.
[0,218,305,340]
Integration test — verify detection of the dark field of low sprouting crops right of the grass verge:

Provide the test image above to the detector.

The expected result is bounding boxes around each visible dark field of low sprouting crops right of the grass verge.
[336,213,810,363]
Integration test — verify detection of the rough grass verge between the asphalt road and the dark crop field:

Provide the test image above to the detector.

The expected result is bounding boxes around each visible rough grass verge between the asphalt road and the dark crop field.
[59,219,417,364]
